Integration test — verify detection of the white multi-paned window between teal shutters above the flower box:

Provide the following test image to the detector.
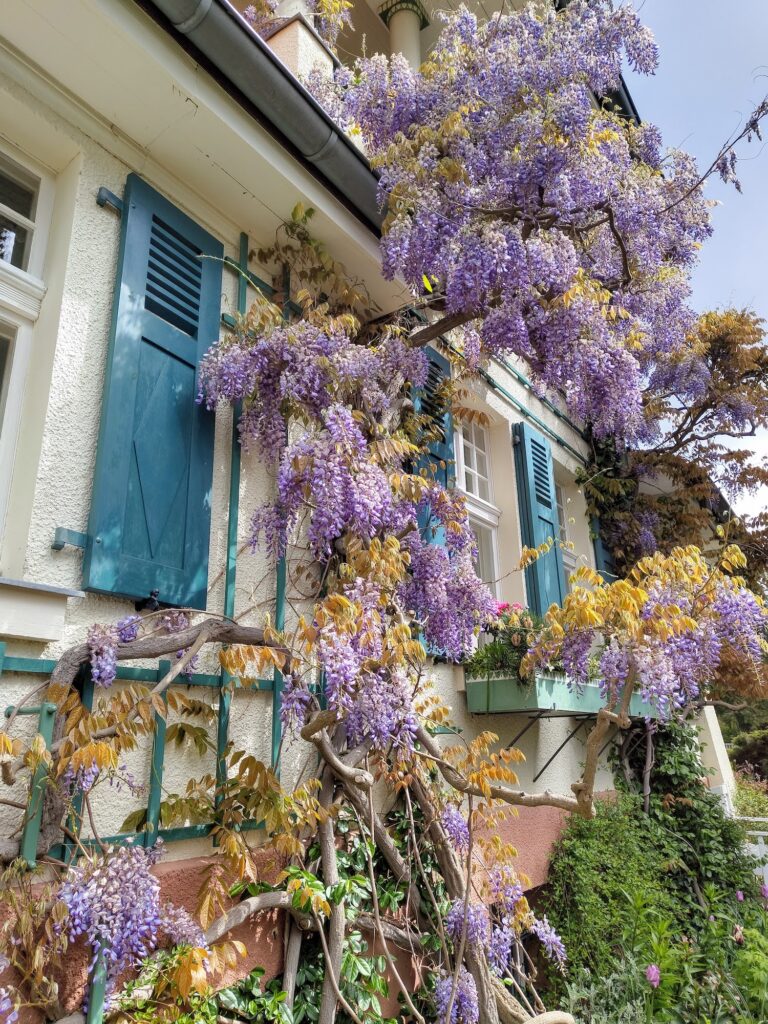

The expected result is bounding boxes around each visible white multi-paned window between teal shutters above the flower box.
[456,423,500,596]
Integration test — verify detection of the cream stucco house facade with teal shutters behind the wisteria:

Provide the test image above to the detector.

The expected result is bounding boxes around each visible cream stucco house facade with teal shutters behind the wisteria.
[0,0,731,1015]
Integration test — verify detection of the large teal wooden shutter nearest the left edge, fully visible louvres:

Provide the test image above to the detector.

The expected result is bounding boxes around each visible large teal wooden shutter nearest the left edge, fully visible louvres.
[84,174,223,608]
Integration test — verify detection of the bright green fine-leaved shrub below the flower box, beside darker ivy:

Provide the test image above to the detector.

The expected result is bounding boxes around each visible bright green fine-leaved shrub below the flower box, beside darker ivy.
[542,797,682,976]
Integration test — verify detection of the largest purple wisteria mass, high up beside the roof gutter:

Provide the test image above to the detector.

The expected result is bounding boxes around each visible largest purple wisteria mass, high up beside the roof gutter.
[313,0,759,439]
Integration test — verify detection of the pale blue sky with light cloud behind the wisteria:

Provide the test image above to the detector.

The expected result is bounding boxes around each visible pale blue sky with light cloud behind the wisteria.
[627,0,768,514]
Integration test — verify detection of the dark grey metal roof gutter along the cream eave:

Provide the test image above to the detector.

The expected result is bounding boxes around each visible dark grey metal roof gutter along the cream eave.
[137,0,383,232]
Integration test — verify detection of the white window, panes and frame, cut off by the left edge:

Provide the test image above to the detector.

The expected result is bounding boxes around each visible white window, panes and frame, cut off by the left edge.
[0,143,53,531]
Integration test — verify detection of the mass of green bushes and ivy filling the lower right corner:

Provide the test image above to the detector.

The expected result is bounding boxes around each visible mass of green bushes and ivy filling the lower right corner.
[544,725,768,1024]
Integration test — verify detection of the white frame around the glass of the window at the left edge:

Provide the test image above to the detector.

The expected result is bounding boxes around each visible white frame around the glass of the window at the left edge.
[0,139,54,532]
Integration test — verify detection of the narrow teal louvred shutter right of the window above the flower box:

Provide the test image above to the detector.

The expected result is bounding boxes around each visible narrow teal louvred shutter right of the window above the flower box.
[514,423,565,615]
